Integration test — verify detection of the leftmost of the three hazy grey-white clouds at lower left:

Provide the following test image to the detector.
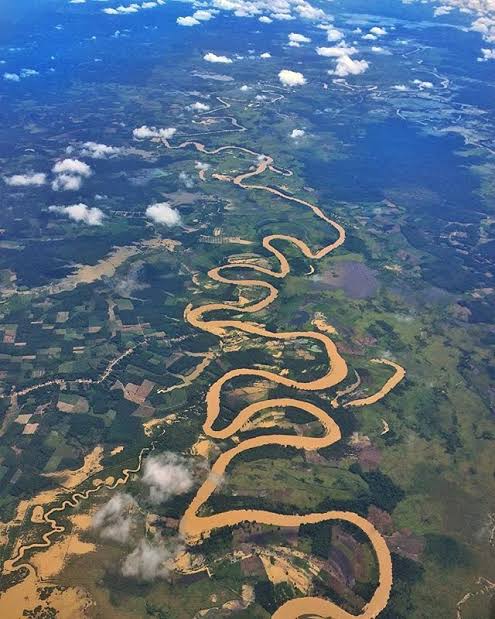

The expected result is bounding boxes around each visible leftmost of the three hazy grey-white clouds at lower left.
[91,493,137,543]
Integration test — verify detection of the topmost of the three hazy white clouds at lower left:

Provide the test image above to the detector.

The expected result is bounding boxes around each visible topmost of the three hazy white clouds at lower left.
[141,452,194,504]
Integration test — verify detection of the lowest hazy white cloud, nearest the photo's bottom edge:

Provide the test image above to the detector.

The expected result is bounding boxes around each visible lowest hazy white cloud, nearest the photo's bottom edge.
[122,539,178,582]
